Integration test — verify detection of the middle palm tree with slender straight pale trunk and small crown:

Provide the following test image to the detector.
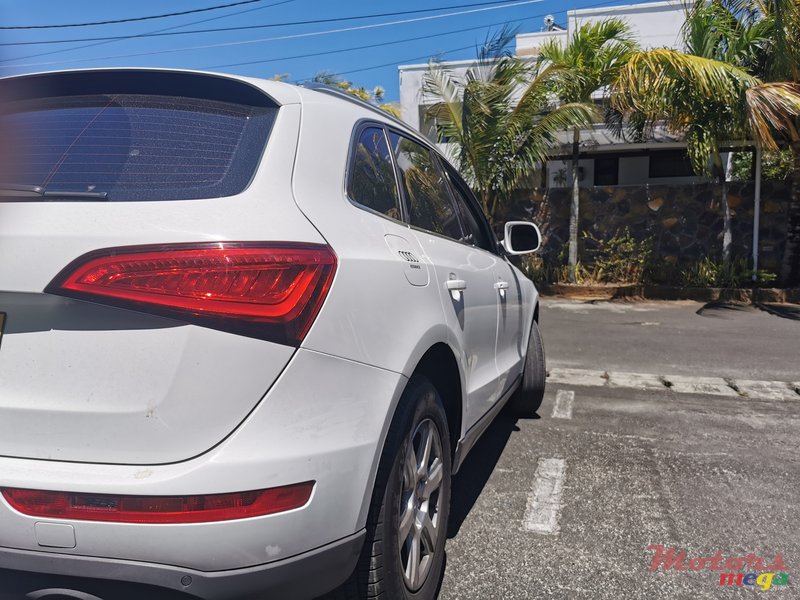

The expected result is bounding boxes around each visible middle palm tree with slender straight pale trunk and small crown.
[539,19,637,283]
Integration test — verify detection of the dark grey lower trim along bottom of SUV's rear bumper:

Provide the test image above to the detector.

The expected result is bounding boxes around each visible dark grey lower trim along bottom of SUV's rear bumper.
[0,530,365,600]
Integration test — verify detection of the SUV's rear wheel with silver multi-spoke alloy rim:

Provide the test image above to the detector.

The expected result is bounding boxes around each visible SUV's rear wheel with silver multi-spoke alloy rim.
[332,375,451,600]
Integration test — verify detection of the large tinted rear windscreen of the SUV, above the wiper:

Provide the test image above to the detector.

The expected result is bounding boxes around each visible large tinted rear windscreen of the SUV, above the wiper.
[0,94,278,201]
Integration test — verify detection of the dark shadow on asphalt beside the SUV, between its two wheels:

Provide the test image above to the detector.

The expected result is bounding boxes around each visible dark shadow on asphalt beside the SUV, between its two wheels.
[447,411,540,538]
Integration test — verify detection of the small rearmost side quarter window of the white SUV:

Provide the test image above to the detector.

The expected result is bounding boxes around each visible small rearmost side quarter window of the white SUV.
[347,127,401,221]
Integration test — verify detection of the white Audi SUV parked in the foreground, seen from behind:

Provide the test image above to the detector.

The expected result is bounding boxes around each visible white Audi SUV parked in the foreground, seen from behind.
[0,69,545,600]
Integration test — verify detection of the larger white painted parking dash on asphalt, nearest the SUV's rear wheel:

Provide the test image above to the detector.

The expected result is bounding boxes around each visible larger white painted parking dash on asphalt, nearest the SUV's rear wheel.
[522,458,567,535]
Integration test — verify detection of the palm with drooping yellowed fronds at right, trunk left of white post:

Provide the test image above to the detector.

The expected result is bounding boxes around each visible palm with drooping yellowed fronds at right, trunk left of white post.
[612,0,800,283]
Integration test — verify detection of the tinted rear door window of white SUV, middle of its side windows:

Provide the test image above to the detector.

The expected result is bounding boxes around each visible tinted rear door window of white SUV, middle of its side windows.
[389,133,464,240]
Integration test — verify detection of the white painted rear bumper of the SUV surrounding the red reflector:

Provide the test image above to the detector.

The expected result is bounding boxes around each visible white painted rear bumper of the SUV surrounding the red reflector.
[0,349,405,576]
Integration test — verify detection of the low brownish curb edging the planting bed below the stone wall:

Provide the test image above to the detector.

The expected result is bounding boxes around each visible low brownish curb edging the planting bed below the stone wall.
[536,283,800,303]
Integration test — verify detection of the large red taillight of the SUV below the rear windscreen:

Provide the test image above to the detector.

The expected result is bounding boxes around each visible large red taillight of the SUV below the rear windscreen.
[45,243,336,345]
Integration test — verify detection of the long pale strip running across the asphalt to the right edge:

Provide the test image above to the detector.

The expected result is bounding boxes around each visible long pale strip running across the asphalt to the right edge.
[547,368,800,400]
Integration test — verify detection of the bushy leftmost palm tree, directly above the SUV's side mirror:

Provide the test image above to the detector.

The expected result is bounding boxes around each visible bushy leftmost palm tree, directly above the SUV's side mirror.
[423,31,596,224]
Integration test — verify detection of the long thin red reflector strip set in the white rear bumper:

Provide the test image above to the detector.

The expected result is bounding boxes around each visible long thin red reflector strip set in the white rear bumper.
[3,481,314,523]
